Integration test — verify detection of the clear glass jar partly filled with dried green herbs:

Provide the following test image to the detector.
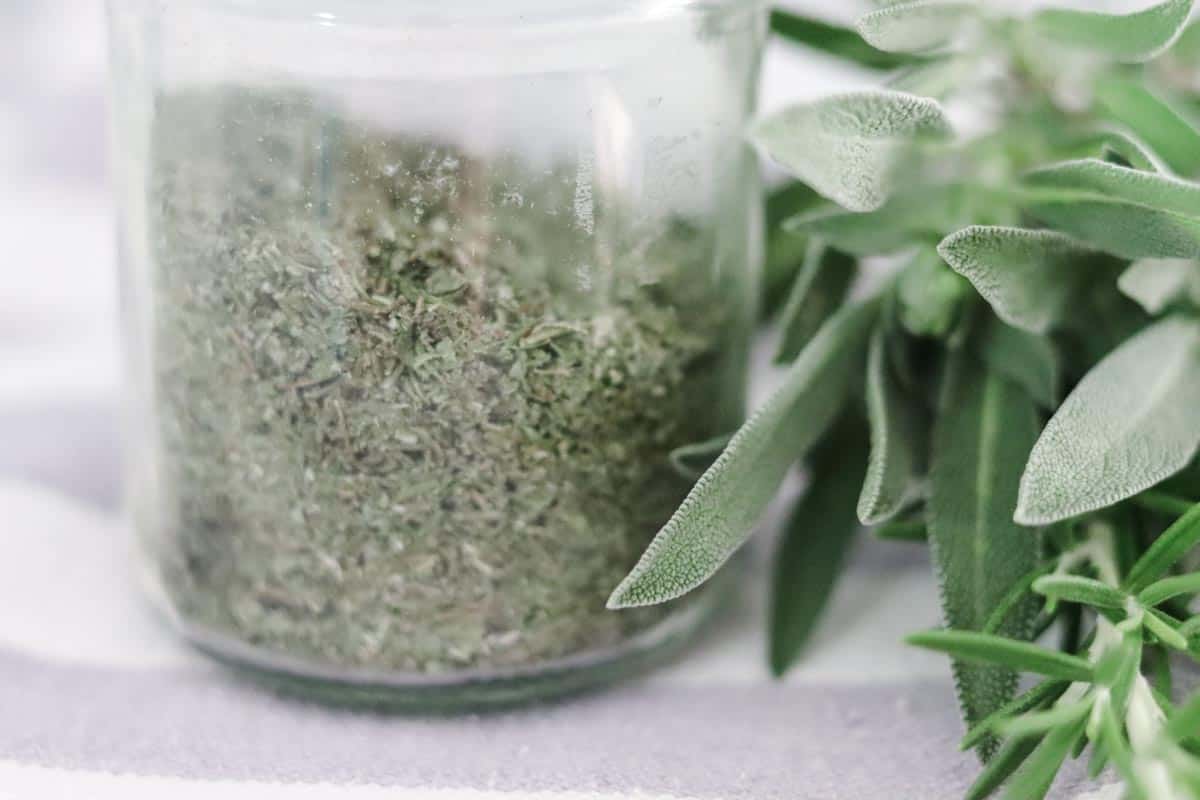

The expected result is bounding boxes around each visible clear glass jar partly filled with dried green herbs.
[109,0,764,706]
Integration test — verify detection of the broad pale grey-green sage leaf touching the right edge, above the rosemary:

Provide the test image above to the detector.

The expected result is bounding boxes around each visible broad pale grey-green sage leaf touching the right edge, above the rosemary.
[1016,317,1200,524]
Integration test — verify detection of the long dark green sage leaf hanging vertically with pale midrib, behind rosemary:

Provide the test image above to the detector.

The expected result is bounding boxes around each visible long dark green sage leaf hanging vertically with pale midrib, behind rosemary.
[928,349,1039,753]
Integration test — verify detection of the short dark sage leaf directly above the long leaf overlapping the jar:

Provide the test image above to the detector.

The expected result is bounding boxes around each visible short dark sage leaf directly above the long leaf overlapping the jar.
[775,241,858,363]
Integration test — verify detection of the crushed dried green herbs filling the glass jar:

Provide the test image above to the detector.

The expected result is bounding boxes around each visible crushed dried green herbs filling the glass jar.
[142,90,743,673]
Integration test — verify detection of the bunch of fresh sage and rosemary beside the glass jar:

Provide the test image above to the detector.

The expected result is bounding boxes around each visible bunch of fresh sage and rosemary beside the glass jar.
[610,0,1200,800]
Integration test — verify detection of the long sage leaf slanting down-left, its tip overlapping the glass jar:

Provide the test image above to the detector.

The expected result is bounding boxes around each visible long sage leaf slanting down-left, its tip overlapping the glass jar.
[608,299,880,608]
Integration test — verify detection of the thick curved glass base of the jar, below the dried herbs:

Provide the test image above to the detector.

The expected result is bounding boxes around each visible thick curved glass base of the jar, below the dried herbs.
[175,587,720,714]
